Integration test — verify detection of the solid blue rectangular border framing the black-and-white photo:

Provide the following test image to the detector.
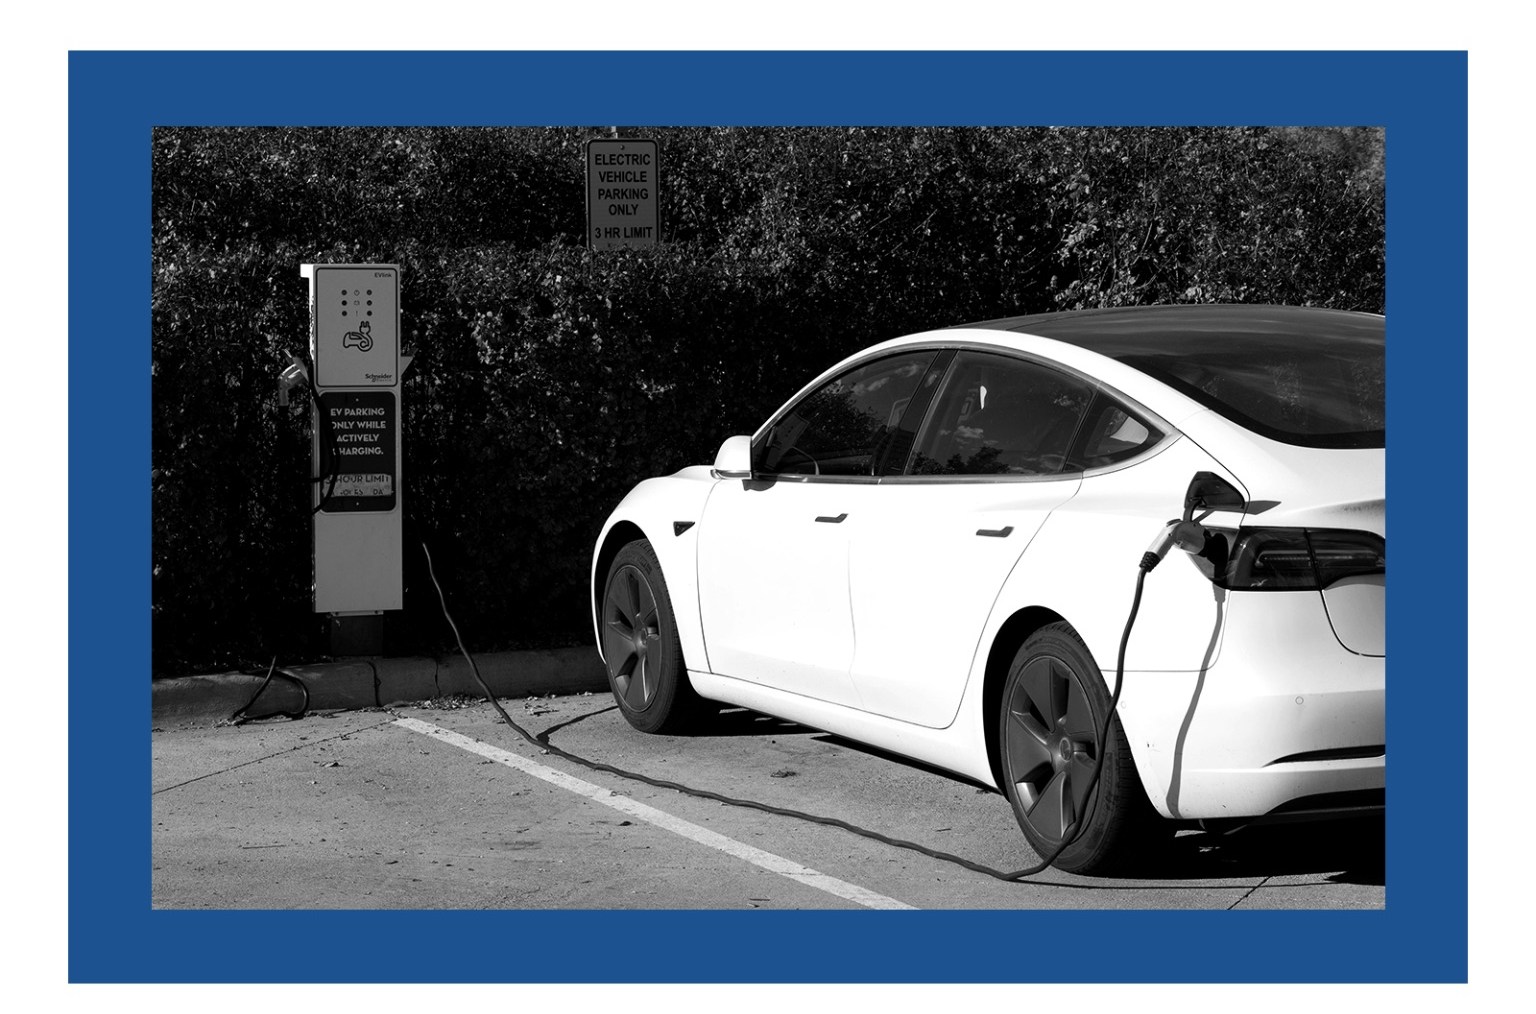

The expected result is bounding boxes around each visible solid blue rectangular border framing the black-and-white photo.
[69,52,1467,982]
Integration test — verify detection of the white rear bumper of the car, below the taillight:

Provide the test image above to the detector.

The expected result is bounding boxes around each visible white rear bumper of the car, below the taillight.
[1120,592,1387,820]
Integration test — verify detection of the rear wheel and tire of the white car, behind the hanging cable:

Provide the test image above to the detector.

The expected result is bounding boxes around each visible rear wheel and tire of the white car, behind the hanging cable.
[997,624,1161,873]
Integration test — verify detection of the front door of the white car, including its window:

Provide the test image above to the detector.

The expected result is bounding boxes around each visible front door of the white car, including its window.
[699,349,940,705]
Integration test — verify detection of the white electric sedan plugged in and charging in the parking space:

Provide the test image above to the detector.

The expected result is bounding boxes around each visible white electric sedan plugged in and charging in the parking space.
[591,306,1387,871]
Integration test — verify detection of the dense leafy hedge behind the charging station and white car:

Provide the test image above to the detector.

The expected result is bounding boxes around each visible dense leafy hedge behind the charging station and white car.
[152,128,1384,674]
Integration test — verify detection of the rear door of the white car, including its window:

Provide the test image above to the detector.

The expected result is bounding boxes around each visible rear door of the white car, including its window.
[849,350,1094,728]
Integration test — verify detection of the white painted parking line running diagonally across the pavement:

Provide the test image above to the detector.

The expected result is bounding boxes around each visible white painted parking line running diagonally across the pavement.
[395,717,912,908]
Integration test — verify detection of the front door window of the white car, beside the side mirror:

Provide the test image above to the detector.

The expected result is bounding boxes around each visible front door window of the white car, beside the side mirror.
[753,349,938,476]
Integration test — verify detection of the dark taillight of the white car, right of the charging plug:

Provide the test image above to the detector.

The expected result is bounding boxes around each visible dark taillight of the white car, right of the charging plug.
[1212,529,1387,592]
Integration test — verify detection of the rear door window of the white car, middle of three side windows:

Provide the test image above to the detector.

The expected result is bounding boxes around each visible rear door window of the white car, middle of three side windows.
[908,352,1094,475]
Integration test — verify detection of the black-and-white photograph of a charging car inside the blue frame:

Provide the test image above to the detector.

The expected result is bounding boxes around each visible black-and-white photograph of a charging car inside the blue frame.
[149,123,1392,909]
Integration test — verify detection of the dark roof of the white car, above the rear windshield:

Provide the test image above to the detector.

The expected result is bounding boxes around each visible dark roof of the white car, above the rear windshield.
[960,303,1385,360]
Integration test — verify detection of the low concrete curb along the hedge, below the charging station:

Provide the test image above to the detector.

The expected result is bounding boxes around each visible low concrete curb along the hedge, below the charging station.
[151,648,608,725]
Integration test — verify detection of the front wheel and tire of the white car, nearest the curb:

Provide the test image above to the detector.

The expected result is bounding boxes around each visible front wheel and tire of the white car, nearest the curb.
[601,539,708,733]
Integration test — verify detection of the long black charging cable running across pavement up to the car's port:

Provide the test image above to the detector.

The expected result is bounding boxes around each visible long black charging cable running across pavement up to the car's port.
[421,542,1157,888]
